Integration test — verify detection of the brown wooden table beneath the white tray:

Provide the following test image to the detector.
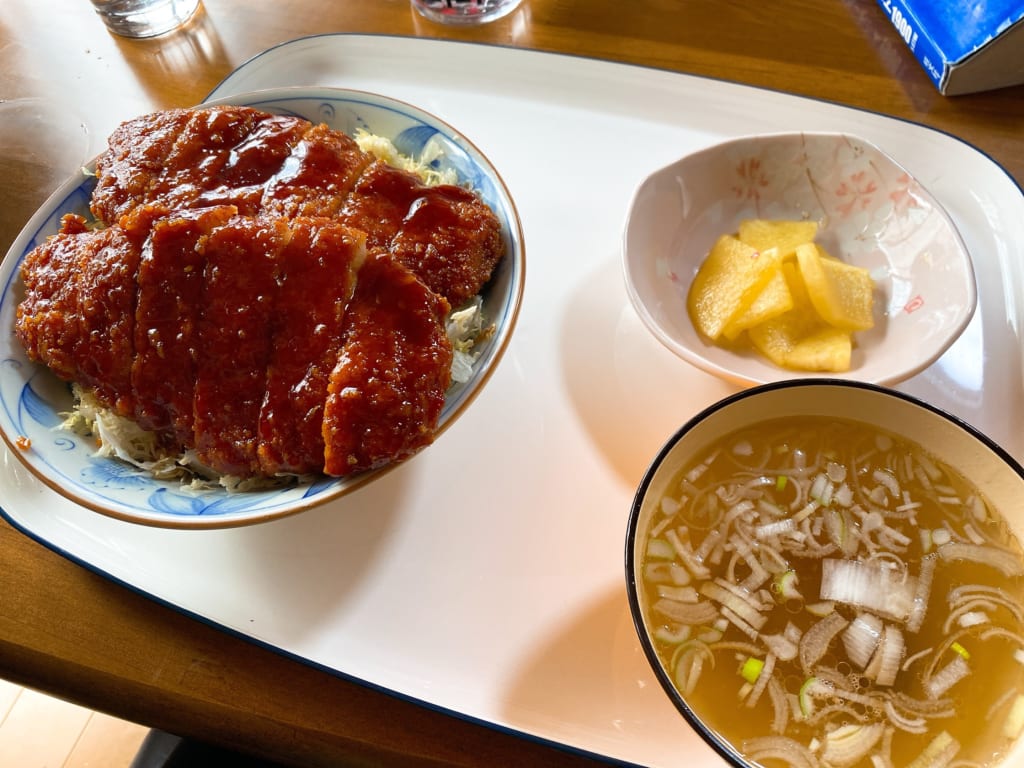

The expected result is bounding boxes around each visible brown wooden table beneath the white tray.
[0,0,1024,766]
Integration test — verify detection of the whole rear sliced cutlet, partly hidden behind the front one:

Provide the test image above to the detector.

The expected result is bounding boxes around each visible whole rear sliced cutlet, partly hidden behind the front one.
[92,106,505,307]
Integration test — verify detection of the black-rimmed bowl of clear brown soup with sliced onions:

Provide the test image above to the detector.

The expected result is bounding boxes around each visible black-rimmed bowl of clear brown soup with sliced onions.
[626,379,1024,768]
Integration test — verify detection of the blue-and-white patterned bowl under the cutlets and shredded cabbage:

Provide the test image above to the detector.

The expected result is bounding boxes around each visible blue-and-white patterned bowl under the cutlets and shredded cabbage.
[0,87,524,528]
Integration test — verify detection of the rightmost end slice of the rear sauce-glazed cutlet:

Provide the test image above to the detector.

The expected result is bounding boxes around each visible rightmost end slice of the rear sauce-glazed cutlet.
[391,184,505,307]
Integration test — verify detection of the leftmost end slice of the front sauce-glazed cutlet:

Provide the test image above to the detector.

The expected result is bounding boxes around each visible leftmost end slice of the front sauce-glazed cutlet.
[14,214,95,381]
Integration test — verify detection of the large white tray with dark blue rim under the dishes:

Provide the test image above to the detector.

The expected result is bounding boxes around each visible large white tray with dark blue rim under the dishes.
[0,35,1024,768]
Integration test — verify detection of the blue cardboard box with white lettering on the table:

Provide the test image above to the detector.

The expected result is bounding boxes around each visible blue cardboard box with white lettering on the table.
[878,0,1024,96]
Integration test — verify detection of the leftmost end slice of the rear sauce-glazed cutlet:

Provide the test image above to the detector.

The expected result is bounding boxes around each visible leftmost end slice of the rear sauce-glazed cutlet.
[90,110,191,225]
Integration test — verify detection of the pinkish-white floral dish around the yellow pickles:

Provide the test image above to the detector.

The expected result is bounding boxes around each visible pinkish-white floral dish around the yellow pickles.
[624,133,977,385]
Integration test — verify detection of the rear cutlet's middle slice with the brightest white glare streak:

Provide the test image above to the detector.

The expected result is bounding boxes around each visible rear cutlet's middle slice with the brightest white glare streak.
[263,124,371,217]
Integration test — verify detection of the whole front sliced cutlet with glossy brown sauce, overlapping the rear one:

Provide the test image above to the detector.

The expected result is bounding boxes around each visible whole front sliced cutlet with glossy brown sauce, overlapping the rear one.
[15,206,453,477]
